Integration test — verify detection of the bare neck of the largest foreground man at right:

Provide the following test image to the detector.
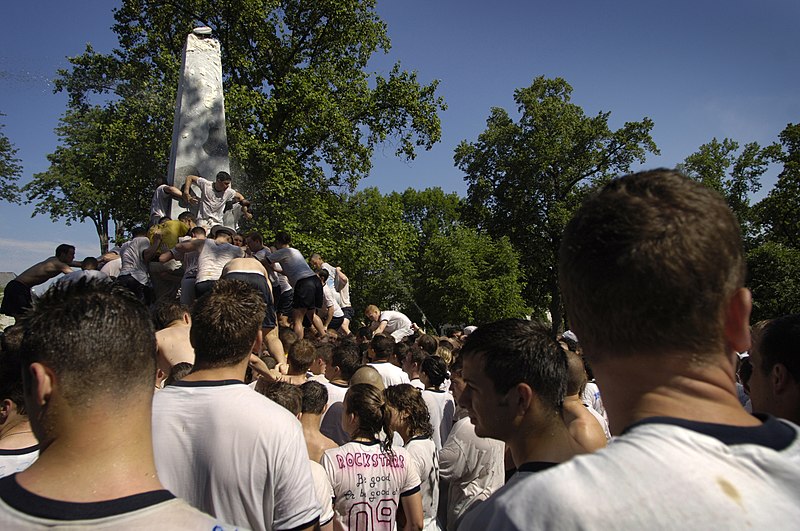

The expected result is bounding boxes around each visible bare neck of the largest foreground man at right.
[592,354,760,433]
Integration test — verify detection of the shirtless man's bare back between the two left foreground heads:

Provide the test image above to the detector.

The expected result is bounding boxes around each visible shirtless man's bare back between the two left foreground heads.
[155,302,194,386]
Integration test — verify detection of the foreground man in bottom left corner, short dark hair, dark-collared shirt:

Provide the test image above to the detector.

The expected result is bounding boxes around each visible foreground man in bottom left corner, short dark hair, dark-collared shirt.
[0,280,232,529]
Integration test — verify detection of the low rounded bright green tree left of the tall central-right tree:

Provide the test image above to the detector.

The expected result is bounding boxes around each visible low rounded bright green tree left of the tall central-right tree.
[417,226,530,327]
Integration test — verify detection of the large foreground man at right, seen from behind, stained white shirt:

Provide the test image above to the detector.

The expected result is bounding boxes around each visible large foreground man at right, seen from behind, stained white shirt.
[460,170,800,529]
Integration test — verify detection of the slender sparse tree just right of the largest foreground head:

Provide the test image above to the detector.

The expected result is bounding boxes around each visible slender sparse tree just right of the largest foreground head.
[678,138,770,248]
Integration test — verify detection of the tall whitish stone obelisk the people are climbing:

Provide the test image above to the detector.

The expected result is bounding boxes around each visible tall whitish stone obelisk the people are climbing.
[167,27,237,227]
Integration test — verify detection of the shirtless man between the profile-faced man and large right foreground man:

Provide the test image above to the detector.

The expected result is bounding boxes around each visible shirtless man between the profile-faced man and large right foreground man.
[561,350,607,452]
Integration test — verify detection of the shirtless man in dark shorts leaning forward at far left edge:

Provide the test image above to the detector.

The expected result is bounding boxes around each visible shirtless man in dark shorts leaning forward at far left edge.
[0,243,81,320]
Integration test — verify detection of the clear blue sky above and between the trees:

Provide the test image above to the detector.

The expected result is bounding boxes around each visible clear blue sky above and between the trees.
[0,0,800,273]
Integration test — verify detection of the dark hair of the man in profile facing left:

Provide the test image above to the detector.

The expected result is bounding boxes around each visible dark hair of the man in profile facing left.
[461,319,567,411]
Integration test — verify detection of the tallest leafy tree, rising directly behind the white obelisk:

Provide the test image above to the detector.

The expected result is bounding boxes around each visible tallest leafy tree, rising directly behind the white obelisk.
[50,0,444,250]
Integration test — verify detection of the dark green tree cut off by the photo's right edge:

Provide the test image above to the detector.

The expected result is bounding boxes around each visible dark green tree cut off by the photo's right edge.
[755,124,800,249]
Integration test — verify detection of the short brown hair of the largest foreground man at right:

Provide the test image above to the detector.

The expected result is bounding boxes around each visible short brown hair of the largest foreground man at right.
[559,169,744,361]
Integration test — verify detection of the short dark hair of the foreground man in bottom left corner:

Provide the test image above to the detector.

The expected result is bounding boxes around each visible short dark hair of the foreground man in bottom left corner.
[20,279,156,408]
